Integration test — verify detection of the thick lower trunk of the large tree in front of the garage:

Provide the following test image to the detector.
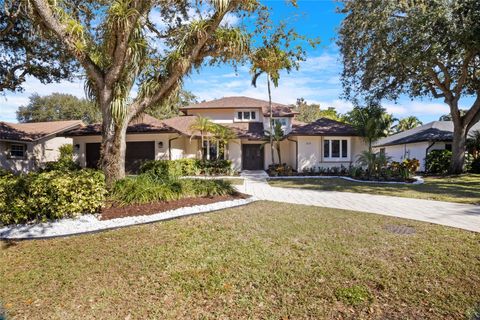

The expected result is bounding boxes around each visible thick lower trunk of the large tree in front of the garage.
[100,114,128,189]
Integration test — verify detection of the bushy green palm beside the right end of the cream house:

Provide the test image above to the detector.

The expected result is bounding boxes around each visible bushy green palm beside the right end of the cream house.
[344,104,395,153]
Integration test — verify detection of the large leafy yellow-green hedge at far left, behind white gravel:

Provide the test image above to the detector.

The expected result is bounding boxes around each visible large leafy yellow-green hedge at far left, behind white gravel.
[0,170,106,224]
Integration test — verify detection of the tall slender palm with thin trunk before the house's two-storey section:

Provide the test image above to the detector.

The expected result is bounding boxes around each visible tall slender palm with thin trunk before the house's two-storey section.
[250,46,295,166]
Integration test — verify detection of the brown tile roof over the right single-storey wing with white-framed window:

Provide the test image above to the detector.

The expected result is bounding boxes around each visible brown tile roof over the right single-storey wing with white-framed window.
[289,118,358,136]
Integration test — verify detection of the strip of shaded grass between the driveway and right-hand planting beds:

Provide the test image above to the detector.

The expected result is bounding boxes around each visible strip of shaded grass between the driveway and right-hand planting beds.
[269,174,480,204]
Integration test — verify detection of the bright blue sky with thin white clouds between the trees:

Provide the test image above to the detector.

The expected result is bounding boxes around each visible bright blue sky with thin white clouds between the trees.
[0,0,472,123]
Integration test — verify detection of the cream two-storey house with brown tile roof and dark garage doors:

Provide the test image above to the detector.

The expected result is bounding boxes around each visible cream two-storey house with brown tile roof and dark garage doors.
[66,97,365,172]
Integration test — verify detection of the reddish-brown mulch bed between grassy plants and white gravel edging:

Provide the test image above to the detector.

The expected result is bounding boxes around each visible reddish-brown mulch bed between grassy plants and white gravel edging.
[100,193,249,220]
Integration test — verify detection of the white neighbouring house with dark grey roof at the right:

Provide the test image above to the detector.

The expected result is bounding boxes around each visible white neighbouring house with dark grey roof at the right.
[374,121,480,171]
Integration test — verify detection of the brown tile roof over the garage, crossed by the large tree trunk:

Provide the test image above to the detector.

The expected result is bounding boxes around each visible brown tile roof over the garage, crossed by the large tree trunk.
[65,114,174,136]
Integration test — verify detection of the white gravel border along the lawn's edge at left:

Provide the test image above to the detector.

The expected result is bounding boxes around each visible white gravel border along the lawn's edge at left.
[0,197,258,240]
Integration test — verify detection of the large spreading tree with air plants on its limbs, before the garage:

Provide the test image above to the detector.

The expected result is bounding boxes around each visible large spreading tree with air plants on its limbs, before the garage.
[19,0,308,186]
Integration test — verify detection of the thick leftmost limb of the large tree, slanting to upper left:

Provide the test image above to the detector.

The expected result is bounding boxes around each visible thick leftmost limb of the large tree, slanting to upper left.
[30,0,104,86]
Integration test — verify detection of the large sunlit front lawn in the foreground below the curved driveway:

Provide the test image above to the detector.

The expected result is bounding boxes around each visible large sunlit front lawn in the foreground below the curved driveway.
[0,202,480,319]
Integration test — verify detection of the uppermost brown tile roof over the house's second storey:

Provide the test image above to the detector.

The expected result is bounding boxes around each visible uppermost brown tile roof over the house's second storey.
[180,97,295,117]
